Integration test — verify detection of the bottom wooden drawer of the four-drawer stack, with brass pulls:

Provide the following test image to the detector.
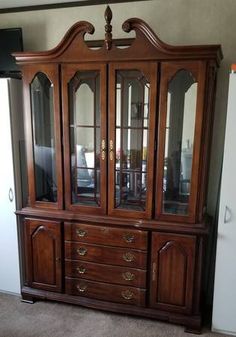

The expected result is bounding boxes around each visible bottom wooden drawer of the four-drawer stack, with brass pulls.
[66,277,146,306]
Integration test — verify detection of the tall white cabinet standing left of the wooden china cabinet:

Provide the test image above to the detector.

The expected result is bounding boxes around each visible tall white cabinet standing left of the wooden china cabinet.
[0,79,22,294]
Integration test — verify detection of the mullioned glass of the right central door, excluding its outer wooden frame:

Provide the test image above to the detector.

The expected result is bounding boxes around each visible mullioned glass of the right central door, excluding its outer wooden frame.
[115,70,150,211]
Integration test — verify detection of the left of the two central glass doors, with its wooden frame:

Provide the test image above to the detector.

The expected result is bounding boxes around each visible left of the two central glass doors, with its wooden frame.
[62,65,107,214]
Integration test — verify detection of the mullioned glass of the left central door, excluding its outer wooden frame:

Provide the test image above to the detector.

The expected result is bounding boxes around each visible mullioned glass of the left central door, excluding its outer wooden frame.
[68,71,100,206]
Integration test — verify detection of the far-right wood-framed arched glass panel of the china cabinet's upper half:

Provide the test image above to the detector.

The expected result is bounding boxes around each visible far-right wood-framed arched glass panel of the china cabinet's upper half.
[156,62,205,222]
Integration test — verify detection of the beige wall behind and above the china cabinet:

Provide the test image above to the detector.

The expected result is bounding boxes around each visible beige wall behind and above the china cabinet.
[0,0,232,214]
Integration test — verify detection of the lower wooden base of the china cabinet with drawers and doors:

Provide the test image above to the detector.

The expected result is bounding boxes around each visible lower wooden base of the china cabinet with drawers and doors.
[17,213,207,333]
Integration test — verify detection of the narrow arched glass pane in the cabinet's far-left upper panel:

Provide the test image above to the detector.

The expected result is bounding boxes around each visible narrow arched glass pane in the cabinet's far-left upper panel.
[30,73,57,202]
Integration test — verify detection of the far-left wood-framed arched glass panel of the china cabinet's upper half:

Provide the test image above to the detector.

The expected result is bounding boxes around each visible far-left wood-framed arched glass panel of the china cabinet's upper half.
[24,65,63,209]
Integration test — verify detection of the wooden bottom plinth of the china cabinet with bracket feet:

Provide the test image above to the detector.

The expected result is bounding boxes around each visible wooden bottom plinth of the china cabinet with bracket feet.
[21,287,201,334]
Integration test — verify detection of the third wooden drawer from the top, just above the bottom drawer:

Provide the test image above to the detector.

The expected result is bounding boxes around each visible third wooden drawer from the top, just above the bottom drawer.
[65,260,146,288]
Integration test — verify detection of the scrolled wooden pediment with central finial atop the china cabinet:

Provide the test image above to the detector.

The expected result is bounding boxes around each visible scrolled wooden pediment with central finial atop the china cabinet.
[13,7,222,64]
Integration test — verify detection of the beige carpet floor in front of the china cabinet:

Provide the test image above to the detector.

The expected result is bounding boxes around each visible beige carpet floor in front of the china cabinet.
[0,293,230,337]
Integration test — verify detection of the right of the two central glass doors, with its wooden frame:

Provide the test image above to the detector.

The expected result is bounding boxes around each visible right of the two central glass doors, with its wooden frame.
[108,63,157,218]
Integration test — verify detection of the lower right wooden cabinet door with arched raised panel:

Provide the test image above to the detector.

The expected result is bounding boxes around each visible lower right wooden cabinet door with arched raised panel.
[150,233,196,313]
